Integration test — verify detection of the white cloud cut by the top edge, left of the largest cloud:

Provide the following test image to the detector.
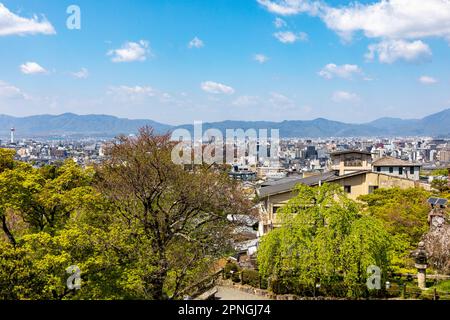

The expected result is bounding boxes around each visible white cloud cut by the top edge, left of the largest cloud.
[257,0,320,16]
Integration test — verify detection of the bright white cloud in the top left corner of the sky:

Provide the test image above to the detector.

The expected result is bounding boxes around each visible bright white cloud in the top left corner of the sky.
[0,3,56,36]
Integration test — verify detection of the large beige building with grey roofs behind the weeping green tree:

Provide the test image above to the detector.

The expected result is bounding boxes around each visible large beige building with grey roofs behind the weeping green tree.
[257,151,430,235]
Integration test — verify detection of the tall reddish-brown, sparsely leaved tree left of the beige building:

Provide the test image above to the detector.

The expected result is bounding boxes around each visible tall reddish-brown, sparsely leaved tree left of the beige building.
[92,128,252,299]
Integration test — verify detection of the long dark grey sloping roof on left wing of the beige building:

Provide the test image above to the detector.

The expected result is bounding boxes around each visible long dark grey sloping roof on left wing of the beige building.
[258,171,337,198]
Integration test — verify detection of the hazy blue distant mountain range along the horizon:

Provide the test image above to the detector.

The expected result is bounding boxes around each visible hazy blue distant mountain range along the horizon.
[0,109,450,138]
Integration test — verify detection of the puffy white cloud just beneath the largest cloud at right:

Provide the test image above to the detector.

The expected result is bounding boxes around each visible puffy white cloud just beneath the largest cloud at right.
[366,40,432,63]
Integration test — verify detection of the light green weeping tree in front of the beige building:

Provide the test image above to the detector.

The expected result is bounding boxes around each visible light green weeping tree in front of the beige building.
[258,184,390,296]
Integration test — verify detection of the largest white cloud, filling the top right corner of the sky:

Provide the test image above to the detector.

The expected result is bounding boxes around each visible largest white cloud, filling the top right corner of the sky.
[321,0,450,40]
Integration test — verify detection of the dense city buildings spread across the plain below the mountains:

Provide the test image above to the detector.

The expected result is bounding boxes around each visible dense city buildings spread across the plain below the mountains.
[4,129,450,178]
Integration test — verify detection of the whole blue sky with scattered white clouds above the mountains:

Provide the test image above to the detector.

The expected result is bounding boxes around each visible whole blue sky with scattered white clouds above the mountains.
[0,0,450,124]
